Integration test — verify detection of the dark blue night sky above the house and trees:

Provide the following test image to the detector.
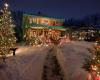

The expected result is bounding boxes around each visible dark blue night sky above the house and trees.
[0,0,100,19]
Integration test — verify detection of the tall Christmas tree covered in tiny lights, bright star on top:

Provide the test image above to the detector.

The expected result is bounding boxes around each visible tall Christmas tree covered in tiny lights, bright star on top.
[0,3,16,56]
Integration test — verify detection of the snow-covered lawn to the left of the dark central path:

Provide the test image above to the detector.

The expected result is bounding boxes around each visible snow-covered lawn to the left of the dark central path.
[0,47,49,80]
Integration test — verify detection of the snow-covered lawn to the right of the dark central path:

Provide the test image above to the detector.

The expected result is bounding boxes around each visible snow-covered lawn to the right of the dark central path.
[57,43,92,80]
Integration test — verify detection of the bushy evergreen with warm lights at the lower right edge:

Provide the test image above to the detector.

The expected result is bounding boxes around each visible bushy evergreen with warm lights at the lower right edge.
[83,43,100,80]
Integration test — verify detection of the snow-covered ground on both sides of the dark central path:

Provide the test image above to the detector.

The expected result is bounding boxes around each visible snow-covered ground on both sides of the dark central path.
[0,41,93,80]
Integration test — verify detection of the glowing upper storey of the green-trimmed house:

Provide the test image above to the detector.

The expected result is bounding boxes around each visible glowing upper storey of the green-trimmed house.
[23,14,65,27]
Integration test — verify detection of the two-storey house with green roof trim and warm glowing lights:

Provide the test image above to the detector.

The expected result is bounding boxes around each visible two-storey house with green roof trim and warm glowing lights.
[23,14,65,44]
